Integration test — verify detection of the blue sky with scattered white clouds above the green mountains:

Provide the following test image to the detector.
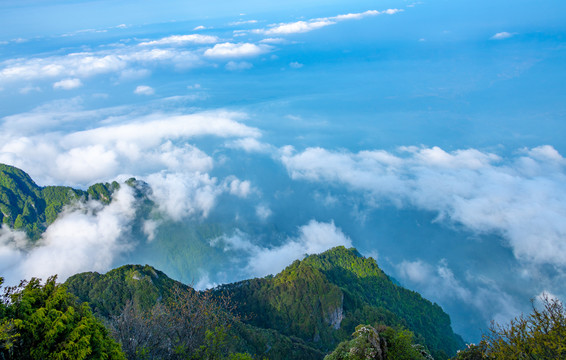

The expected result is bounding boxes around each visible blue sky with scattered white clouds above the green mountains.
[0,0,566,341]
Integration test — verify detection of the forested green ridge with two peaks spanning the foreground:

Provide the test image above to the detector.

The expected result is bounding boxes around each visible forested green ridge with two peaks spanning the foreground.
[65,247,464,359]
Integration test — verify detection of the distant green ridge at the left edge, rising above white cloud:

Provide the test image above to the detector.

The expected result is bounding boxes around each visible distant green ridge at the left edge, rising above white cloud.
[0,164,125,241]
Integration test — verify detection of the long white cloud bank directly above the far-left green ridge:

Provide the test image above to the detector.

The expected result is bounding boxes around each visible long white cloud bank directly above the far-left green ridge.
[0,102,261,186]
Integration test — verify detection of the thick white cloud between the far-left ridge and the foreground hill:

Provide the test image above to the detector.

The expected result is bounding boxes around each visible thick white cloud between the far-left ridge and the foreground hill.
[0,186,139,284]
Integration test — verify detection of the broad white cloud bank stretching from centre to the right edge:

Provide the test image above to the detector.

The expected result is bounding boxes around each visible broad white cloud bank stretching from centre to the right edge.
[281,146,566,266]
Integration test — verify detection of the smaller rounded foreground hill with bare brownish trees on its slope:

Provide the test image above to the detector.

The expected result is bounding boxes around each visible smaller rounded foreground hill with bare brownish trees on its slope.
[66,265,324,359]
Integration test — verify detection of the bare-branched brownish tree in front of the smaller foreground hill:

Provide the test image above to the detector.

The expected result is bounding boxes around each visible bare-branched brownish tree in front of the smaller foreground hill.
[109,285,244,360]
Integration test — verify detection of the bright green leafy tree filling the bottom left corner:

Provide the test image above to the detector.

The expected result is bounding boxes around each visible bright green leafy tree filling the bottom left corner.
[0,276,125,360]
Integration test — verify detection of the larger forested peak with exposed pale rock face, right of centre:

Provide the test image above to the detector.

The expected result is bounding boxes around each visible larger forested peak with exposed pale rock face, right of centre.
[216,247,464,359]
